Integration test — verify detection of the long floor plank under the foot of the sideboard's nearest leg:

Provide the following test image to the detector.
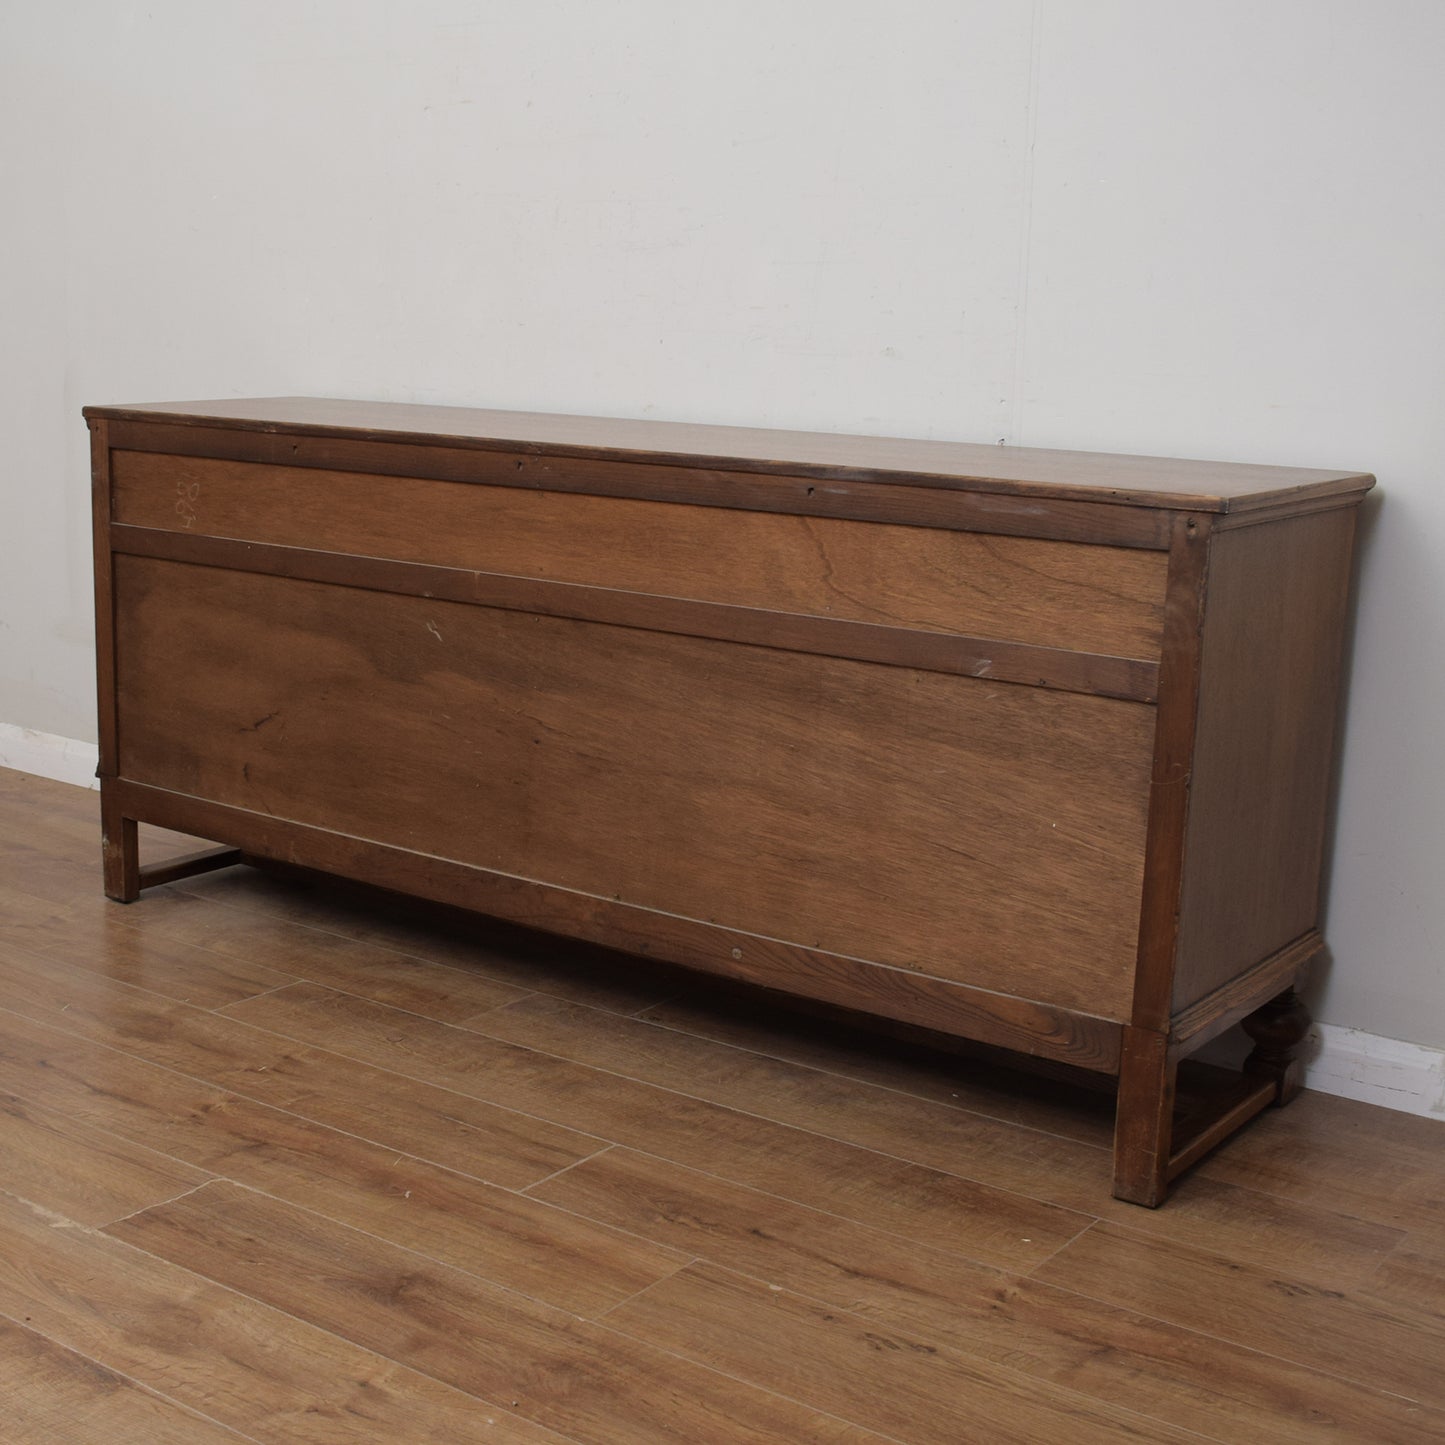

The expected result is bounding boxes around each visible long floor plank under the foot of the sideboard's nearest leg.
[459,994,1400,1287]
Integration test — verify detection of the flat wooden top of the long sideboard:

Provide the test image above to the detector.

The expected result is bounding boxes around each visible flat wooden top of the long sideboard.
[85,396,1374,512]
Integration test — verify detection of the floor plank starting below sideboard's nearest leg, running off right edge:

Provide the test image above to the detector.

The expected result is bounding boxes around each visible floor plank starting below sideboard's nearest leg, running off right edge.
[1036,1222,1445,1409]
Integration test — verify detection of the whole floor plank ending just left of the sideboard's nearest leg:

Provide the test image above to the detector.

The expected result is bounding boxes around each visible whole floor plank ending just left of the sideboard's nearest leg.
[216,984,1091,1266]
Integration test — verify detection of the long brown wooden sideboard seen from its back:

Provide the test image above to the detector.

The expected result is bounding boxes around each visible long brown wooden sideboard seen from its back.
[85,397,1373,1205]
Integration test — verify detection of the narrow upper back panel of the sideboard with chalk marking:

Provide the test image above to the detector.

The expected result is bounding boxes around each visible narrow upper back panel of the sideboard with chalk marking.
[113,451,1165,657]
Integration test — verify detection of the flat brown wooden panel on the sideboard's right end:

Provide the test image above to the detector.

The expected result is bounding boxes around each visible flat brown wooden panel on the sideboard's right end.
[1173,510,1355,1010]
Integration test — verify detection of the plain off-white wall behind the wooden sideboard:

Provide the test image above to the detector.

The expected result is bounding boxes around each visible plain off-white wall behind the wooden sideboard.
[0,0,1445,1046]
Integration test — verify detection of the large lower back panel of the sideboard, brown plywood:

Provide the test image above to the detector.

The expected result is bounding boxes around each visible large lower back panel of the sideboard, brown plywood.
[109,558,1153,1019]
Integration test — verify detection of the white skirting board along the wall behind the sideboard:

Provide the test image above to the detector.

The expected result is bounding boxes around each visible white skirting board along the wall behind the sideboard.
[0,723,1445,1120]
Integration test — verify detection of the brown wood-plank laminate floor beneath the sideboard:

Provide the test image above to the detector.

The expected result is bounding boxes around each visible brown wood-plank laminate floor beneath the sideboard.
[0,772,1445,1445]
